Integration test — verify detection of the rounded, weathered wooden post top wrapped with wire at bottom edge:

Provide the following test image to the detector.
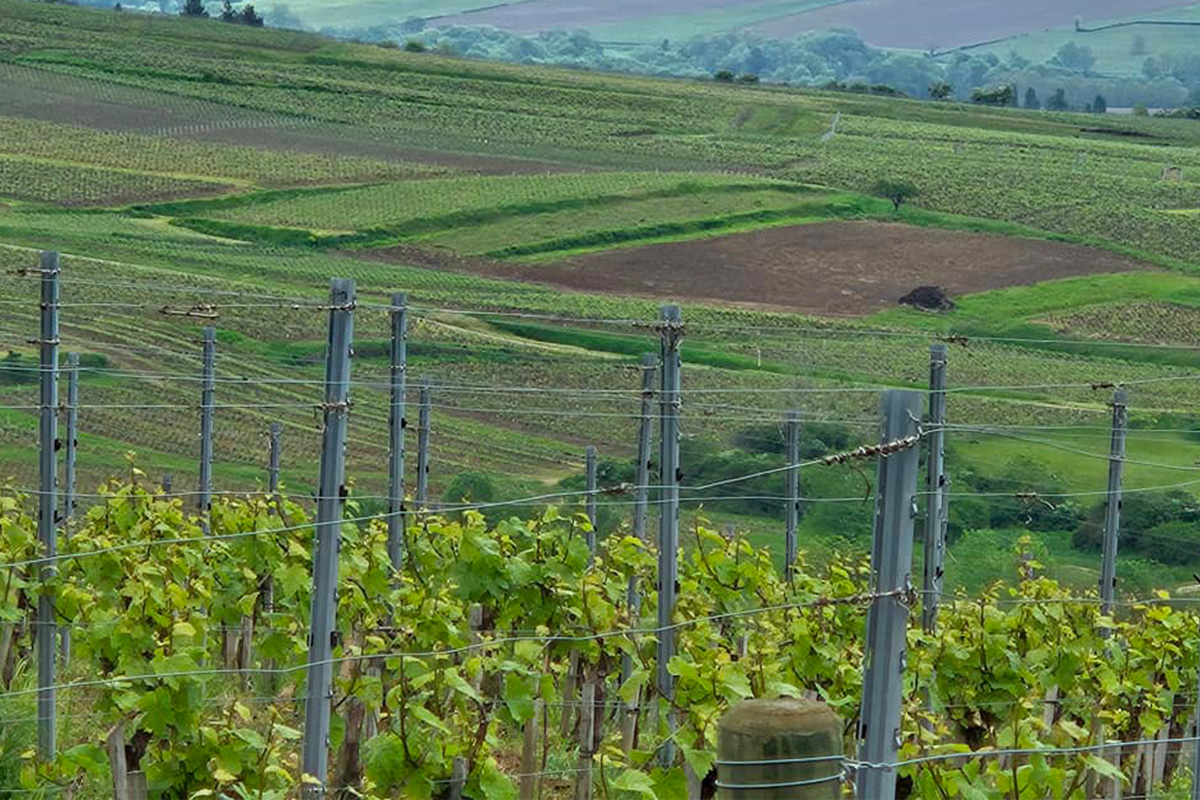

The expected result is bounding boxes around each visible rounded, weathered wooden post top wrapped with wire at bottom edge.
[716,697,844,800]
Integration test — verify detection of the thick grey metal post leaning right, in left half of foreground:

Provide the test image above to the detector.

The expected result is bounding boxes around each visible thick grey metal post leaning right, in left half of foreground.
[302,278,354,798]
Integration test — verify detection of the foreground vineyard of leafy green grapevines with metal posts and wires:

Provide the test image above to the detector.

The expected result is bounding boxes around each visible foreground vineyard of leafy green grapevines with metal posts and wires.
[0,254,1200,798]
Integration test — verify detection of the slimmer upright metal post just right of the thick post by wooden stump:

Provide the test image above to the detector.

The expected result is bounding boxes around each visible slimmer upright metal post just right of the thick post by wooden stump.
[920,343,949,633]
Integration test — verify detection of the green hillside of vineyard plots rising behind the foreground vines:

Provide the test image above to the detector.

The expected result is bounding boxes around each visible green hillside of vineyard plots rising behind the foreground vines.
[0,0,1200,588]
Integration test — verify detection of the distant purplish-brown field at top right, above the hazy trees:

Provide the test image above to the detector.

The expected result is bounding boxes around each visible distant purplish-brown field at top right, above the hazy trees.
[750,0,1190,49]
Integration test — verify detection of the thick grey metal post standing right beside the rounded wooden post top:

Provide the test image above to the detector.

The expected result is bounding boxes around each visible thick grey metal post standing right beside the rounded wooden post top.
[857,390,923,800]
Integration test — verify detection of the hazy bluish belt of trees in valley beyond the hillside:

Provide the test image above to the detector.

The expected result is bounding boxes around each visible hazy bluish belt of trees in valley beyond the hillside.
[312,20,1200,109]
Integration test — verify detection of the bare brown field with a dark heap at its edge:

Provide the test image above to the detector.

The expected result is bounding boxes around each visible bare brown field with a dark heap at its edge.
[358,222,1148,315]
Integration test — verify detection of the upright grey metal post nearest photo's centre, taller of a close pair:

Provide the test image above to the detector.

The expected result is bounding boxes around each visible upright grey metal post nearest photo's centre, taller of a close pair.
[655,306,683,765]
